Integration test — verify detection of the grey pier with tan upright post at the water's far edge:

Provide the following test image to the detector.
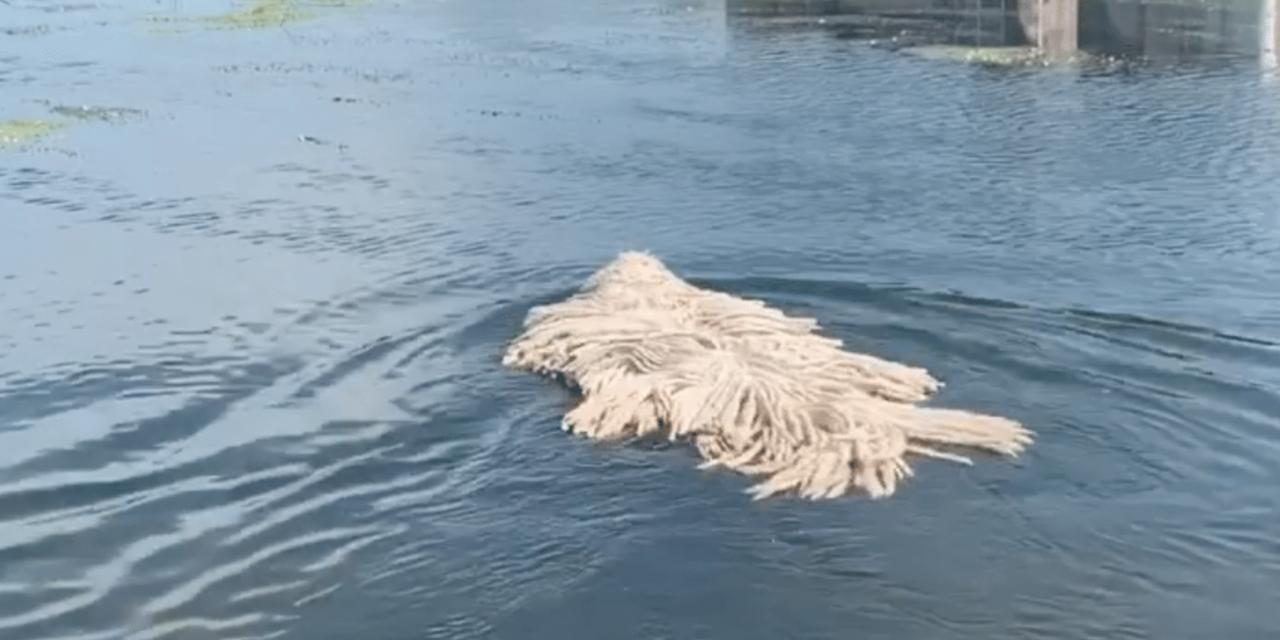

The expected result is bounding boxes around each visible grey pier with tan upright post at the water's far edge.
[724,0,1280,61]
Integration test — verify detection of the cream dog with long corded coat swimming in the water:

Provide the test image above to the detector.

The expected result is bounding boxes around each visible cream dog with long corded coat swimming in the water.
[503,252,1032,499]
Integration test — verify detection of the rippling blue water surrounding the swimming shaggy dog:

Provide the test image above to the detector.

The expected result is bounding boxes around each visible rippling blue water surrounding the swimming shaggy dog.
[0,0,1280,640]
